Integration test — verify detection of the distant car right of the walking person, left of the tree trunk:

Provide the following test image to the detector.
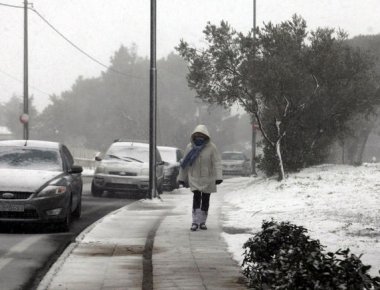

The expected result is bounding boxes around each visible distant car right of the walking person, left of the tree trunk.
[222,151,251,176]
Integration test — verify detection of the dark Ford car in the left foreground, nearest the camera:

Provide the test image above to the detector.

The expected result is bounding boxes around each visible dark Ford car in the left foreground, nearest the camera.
[0,140,83,231]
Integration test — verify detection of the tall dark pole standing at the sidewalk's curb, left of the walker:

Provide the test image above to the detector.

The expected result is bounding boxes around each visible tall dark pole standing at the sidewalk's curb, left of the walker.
[149,0,157,199]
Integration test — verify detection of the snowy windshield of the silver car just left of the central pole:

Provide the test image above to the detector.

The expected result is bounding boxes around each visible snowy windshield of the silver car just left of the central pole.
[105,146,149,162]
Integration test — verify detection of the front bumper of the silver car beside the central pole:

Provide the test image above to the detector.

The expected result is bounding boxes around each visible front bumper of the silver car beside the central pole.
[94,174,149,191]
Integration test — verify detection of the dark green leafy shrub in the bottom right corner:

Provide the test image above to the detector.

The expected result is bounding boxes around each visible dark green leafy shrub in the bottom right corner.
[242,220,380,290]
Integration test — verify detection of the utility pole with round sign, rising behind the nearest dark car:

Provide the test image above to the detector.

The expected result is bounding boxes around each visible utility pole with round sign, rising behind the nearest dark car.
[20,0,29,140]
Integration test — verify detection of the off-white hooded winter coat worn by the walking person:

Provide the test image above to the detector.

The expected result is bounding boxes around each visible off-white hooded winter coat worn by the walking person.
[178,125,223,193]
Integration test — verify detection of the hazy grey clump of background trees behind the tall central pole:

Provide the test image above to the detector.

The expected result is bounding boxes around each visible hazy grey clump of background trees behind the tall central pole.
[38,46,235,150]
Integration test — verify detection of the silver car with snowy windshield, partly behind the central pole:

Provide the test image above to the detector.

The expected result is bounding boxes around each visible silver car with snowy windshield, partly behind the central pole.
[91,141,164,197]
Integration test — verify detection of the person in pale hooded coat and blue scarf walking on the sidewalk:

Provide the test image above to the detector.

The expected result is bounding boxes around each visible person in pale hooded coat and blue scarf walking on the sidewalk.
[178,125,223,231]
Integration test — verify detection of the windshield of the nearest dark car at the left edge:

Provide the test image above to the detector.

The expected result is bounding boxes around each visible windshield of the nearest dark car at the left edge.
[0,146,62,171]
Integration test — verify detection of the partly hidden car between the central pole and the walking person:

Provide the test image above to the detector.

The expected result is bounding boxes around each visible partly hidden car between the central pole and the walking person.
[157,146,183,191]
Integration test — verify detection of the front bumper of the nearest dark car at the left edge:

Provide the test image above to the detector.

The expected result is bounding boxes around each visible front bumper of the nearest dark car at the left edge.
[0,195,69,222]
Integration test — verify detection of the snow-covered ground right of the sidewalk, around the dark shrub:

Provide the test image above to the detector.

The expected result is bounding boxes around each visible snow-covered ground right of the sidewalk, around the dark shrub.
[220,163,380,276]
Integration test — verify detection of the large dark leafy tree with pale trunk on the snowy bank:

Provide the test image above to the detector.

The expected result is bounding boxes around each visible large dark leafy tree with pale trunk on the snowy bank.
[177,15,378,179]
